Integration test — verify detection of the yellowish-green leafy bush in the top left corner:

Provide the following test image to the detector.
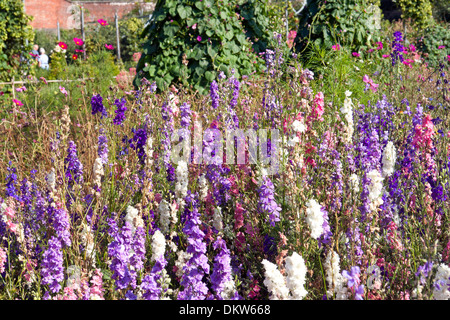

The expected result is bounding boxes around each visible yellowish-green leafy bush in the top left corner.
[0,0,33,80]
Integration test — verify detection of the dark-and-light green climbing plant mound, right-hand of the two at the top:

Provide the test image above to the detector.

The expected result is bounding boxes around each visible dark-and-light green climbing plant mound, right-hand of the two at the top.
[295,0,379,56]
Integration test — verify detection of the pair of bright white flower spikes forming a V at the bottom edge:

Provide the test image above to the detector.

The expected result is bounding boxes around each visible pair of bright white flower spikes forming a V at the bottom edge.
[262,252,308,300]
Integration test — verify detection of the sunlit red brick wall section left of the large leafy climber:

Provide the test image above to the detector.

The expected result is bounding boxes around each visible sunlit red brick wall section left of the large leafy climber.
[25,0,155,29]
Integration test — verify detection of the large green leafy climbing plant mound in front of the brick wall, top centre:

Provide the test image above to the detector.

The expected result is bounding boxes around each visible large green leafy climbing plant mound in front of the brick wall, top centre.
[134,0,268,93]
